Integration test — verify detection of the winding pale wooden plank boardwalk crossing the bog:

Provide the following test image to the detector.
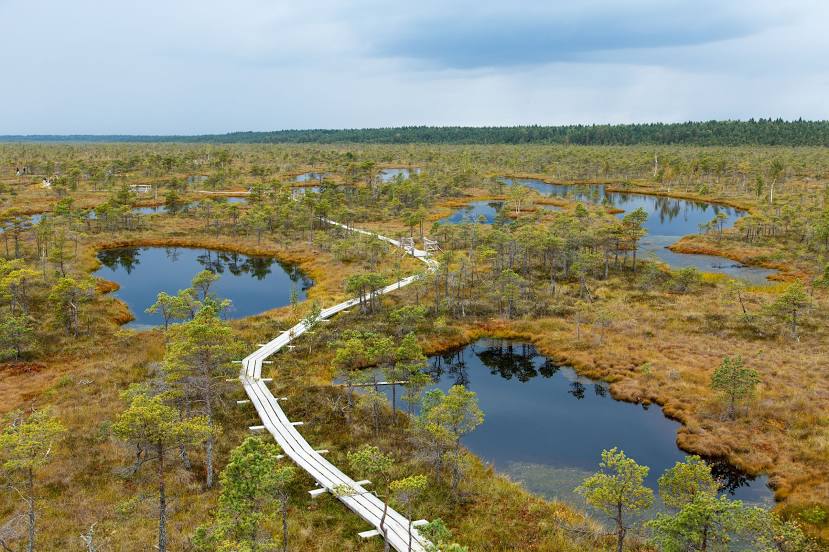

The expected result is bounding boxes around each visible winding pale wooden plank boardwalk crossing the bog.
[239,220,437,552]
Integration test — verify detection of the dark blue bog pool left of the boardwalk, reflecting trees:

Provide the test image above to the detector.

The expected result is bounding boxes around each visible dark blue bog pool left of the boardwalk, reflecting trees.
[95,247,313,328]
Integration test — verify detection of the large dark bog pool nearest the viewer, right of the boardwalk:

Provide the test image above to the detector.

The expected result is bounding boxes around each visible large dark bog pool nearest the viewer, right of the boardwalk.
[384,339,773,504]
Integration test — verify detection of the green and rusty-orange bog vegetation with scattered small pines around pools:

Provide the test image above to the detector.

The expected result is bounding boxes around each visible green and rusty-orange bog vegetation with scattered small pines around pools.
[0,141,829,551]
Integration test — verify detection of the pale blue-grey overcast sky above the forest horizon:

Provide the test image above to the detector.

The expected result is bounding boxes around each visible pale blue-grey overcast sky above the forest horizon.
[0,0,829,134]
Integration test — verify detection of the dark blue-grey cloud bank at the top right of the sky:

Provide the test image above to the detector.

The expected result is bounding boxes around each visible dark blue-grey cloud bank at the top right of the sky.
[368,0,784,69]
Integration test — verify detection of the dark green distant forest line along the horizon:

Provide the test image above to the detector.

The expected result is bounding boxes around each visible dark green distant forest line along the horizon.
[0,119,829,146]
